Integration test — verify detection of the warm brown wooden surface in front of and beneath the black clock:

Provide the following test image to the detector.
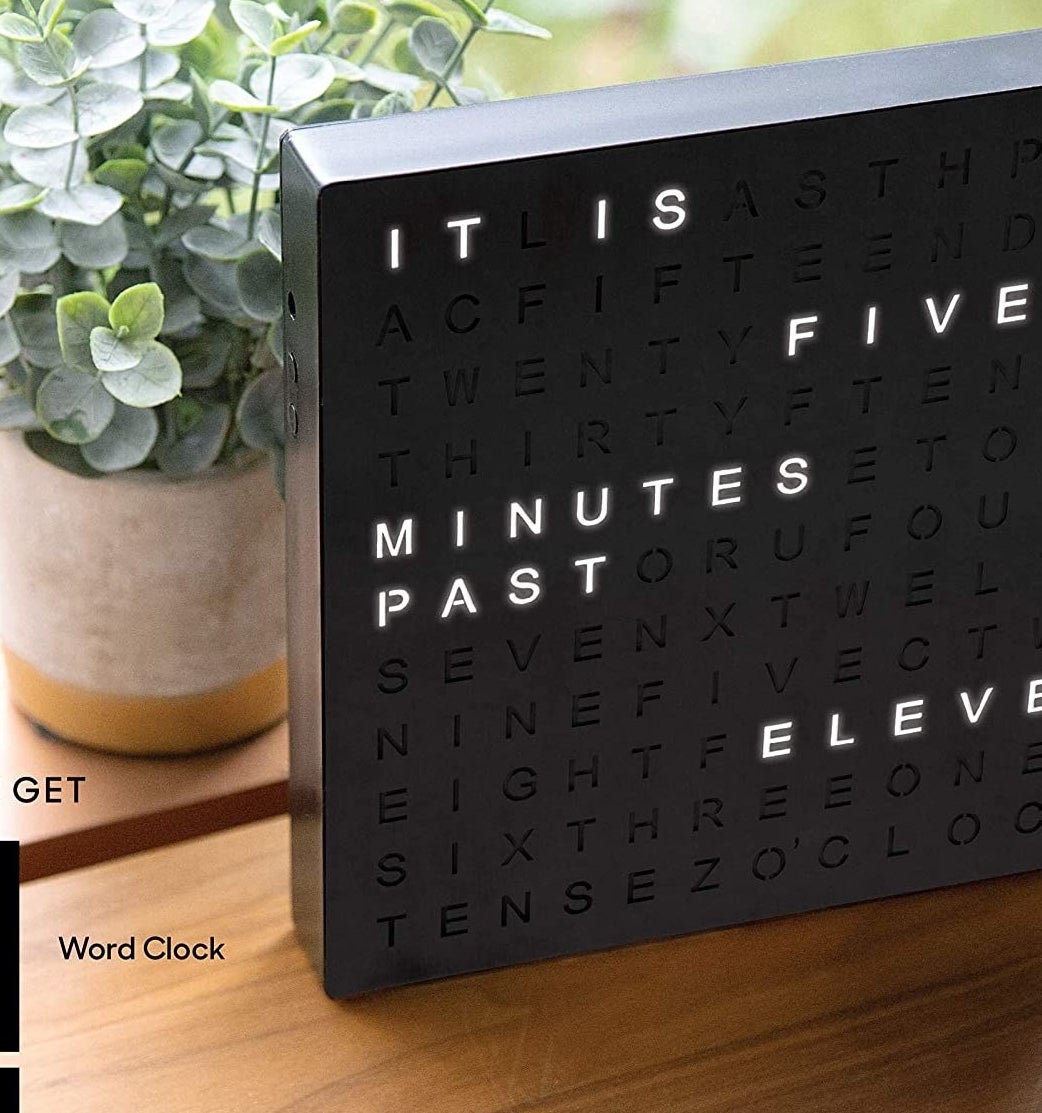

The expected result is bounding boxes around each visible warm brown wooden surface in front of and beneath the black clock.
[12,818,1042,1113]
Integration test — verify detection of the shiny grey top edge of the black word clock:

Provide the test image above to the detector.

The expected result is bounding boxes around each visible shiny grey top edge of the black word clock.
[284,30,1042,190]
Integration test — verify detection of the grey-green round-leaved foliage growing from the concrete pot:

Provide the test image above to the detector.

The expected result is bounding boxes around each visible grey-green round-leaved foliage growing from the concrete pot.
[0,0,549,477]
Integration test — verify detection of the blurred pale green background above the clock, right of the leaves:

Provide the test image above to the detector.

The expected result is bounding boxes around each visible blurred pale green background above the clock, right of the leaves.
[471,0,1042,96]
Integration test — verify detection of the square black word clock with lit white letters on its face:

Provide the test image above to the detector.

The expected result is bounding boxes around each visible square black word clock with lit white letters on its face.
[283,32,1042,996]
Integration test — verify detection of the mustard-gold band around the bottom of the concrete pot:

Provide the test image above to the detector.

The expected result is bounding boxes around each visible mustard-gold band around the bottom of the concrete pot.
[3,647,287,756]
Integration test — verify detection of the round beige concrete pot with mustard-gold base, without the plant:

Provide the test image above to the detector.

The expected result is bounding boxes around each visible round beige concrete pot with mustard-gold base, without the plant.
[0,433,286,755]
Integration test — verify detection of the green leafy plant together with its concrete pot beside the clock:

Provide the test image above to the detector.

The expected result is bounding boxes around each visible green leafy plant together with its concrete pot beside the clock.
[0,0,547,752]
